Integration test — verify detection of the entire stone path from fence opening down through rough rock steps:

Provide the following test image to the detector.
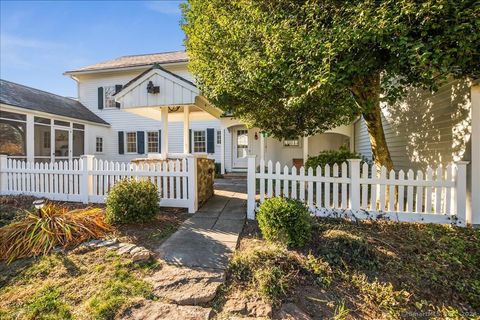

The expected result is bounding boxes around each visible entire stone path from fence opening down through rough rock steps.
[130,179,246,319]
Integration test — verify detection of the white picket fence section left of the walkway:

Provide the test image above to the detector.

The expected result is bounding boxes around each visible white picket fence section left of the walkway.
[0,155,198,213]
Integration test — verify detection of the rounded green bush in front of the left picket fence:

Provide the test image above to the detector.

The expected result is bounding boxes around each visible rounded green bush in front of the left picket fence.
[106,179,160,223]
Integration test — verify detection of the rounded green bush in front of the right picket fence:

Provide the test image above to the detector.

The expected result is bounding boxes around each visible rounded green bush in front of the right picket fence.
[257,197,312,247]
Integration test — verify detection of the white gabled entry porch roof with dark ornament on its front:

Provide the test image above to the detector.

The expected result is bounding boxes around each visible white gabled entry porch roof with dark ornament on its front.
[114,64,222,118]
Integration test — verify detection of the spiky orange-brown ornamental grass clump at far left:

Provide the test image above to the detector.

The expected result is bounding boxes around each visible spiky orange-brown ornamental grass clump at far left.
[0,204,112,262]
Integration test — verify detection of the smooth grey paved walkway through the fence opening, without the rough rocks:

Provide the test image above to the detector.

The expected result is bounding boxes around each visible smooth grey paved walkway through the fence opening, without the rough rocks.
[156,179,246,270]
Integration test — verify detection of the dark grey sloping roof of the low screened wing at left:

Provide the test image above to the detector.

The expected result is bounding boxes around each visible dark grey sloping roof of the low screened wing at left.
[0,79,108,125]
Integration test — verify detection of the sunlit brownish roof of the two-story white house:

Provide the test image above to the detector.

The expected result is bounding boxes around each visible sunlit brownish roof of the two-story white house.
[65,51,188,74]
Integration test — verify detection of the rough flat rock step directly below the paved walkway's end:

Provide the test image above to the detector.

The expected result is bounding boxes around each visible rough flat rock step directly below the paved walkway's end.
[146,265,225,305]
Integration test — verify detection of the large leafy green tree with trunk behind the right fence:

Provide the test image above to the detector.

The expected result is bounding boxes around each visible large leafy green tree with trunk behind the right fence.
[182,0,480,169]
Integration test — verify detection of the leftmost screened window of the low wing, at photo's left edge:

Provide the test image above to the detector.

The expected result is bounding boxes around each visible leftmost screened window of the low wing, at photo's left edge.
[0,111,27,156]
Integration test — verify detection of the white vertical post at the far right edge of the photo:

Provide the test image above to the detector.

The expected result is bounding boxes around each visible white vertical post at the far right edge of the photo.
[467,84,480,225]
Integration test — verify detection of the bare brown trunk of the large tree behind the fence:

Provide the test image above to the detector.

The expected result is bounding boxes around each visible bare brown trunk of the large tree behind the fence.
[352,74,393,171]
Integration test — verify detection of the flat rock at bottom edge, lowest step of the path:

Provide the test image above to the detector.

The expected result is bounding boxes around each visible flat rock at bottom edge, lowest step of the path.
[122,300,212,320]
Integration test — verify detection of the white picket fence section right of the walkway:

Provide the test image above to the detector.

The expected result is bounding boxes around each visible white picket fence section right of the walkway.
[247,156,471,226]
